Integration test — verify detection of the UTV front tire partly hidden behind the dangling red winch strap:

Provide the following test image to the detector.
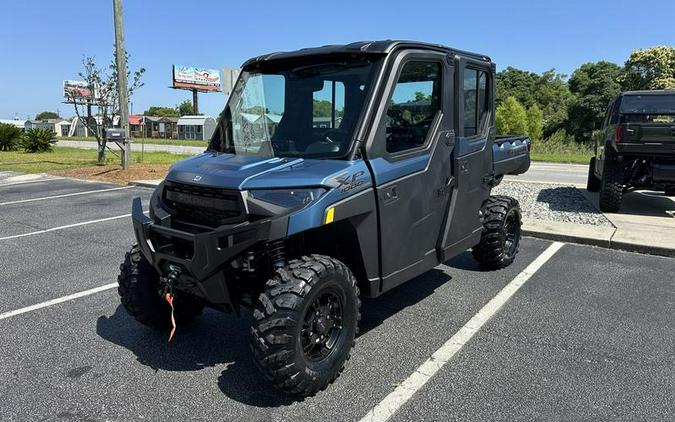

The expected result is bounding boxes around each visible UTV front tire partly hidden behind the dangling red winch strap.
[117,245,204,330]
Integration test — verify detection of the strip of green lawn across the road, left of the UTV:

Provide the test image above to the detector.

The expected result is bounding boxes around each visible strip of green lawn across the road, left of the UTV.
[0,147,190,173]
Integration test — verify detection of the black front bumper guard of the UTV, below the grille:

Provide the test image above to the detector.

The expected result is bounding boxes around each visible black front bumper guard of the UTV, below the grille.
[131,198,288,304]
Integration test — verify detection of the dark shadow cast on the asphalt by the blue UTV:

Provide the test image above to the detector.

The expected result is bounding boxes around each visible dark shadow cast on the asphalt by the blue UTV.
[96,264,454,407]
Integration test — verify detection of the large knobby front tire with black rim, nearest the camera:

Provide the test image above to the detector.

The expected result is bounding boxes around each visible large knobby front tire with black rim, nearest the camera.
[251,255,361,397]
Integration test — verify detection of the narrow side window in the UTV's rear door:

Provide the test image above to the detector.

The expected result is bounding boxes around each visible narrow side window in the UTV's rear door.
[462,69,490,136]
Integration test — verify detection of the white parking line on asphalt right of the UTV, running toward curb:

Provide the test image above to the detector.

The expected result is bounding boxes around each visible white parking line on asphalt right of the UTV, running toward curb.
[361,242,564,422]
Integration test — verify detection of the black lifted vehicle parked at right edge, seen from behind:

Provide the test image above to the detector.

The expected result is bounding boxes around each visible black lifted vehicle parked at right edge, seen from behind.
[587,90,675,212]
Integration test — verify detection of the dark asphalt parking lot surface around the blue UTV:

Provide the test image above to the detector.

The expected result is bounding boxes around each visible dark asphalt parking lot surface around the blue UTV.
[0,179,675,421]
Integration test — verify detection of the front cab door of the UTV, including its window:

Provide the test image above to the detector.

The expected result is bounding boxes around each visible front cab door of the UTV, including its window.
[368,50,454,292]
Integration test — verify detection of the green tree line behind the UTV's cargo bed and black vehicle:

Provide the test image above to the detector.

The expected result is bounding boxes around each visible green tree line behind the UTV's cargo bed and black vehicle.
[495,46,675,143]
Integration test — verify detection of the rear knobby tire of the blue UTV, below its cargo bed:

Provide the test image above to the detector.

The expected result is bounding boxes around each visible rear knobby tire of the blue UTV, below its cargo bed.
[471,196,522,270]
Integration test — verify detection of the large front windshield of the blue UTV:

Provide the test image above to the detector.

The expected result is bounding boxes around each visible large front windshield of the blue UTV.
[209,58,377,158]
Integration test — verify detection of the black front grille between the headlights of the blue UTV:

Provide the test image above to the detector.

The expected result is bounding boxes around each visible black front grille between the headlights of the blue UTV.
[162,181,246,228]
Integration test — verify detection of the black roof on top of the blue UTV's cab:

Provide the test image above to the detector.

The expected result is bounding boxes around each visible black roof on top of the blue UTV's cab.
[242,40,491,67]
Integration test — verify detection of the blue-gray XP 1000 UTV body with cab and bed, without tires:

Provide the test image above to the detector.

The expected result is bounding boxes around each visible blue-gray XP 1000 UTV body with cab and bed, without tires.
[133,41,530,309]
